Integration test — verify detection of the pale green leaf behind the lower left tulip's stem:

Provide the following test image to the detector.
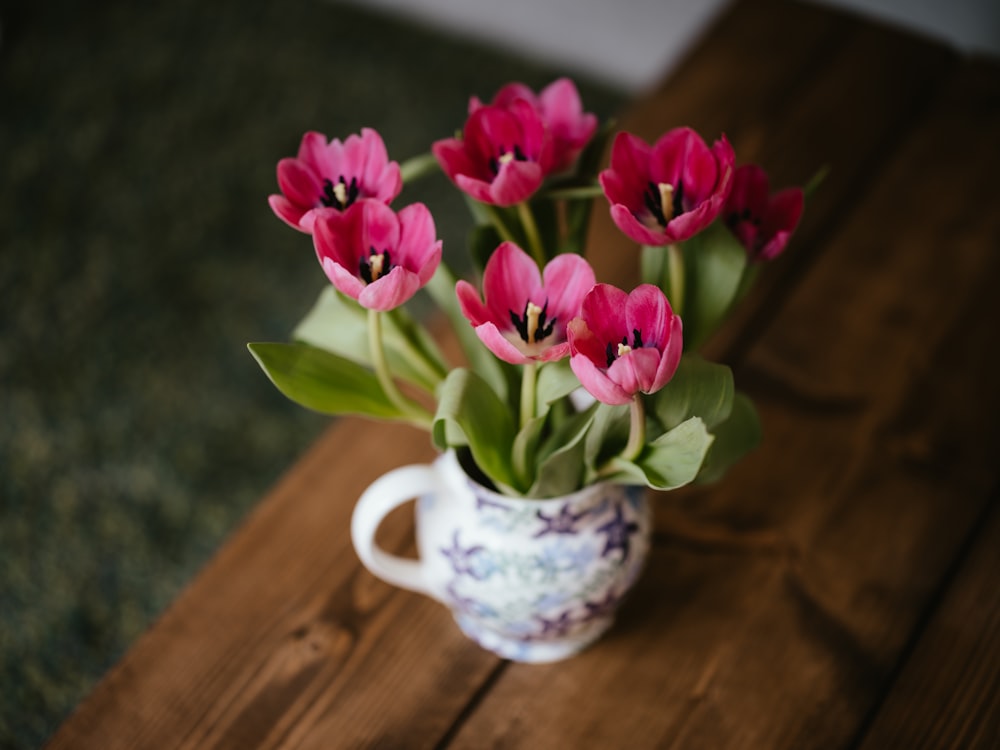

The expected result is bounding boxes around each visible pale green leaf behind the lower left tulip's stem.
[292,286,447,393]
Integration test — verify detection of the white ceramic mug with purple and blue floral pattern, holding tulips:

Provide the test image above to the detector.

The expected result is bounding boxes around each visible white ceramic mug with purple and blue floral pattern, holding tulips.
[351,451,650,662]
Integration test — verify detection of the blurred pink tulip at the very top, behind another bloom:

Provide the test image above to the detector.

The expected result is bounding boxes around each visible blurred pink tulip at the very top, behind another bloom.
[469,78,597,172]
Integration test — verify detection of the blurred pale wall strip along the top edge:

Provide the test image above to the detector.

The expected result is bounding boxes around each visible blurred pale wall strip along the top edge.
[335,0,1000,91]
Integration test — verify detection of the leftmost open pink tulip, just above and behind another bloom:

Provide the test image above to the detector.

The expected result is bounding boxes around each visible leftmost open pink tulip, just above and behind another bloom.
[268,128,403,233]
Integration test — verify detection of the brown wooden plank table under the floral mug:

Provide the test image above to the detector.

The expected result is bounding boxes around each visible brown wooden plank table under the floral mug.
[50,0,1000,750]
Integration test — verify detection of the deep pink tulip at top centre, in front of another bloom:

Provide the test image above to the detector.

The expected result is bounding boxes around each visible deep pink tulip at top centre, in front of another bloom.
[432,99,554,206]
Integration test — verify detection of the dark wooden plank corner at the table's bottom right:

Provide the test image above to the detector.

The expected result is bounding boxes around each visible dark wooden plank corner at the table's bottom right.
[861,500,1000,750]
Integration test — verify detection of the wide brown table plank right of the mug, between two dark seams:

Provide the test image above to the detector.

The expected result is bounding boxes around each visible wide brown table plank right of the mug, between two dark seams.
[446,45,1000,748]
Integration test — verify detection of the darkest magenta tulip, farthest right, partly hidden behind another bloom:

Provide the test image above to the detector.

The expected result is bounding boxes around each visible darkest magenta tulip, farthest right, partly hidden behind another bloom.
[722,164,805,261]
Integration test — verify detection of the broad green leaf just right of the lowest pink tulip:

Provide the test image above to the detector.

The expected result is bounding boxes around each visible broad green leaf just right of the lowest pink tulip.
[646,354,735,430]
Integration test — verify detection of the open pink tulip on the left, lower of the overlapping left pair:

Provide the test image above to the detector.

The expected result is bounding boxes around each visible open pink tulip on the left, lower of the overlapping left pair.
[313,198,441,311]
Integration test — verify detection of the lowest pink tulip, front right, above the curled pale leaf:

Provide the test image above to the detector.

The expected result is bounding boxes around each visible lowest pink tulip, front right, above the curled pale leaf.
[567,284,683,404]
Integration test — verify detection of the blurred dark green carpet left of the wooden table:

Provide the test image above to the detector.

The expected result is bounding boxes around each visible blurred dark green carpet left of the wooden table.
[0,0,623,748]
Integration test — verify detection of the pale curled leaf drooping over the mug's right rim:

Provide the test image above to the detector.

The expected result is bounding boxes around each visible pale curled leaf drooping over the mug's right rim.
[610,417,712,490]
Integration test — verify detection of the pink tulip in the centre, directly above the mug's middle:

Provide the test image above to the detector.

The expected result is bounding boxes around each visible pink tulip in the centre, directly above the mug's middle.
[455,242,595,365]
